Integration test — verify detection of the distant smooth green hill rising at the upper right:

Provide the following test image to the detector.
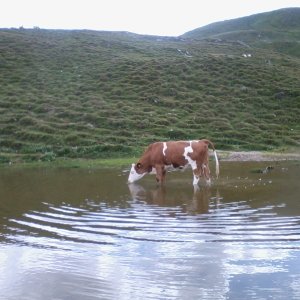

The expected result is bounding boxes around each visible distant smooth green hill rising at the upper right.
[183,7,300,58]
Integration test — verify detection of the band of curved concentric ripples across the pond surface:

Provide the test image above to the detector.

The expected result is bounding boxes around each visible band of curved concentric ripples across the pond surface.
[6,199,300,251]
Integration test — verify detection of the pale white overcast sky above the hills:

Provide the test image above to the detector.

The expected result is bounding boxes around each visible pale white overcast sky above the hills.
[0,0,300,36]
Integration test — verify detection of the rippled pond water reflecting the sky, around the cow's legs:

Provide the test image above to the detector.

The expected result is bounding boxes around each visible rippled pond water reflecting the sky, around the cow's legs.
[0,162,300,300]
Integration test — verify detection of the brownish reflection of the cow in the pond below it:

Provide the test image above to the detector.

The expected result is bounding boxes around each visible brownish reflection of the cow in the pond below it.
[128,183,219,214]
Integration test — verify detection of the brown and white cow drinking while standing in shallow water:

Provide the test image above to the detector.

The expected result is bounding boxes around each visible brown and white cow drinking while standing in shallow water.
[128,140,219,185]
